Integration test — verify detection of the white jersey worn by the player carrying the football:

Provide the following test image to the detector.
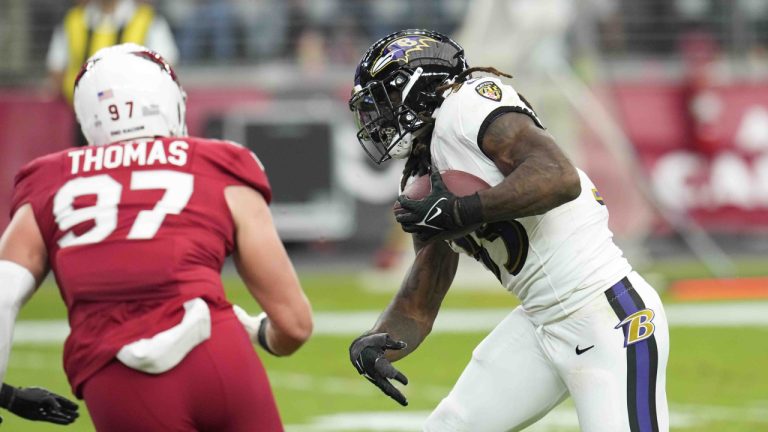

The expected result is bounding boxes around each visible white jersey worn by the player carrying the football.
[431,77,632,323]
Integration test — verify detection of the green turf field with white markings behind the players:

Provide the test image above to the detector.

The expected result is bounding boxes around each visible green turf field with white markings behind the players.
[0,261,768,432]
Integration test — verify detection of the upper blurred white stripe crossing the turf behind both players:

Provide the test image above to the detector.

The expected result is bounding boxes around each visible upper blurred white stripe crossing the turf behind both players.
[14,302,768,343]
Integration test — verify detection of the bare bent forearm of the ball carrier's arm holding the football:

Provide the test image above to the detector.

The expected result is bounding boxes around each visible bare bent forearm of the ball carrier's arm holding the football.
[478,157,581,222]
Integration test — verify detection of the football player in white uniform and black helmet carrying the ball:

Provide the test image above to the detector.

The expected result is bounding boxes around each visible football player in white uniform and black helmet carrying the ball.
[350,30,669,432]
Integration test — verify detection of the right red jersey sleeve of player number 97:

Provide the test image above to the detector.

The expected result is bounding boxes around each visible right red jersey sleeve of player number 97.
[200,141,272,203]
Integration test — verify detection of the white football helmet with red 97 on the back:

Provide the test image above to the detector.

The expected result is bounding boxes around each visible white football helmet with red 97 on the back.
[74,43,187,145]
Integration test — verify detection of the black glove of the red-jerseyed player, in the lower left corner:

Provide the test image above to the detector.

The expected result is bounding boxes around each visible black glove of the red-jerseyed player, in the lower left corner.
[0,384,80,425]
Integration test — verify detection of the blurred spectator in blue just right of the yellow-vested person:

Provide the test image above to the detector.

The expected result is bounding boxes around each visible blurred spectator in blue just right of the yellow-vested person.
[179,0,237,62]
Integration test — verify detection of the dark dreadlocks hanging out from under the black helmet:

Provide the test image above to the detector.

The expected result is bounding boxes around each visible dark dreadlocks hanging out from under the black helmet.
[400,67,512,190]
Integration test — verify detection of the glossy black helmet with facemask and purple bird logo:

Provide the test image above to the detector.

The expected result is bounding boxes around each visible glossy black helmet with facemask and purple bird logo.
[349,29,468,164]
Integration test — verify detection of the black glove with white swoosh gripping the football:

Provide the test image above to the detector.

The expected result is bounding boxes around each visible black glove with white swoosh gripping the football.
[395,170,483,242]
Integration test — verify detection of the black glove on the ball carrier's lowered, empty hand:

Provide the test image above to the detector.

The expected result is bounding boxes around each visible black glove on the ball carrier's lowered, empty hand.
[349,333,408,406]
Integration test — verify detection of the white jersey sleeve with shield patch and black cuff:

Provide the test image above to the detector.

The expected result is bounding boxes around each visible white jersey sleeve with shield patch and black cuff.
[458,78,544,149]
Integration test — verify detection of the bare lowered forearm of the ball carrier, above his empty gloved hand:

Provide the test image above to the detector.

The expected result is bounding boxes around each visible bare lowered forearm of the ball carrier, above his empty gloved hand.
[370,242,459,361]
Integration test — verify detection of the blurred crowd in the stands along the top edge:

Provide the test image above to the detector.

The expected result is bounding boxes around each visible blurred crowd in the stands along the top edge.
[0,0,768,77]
